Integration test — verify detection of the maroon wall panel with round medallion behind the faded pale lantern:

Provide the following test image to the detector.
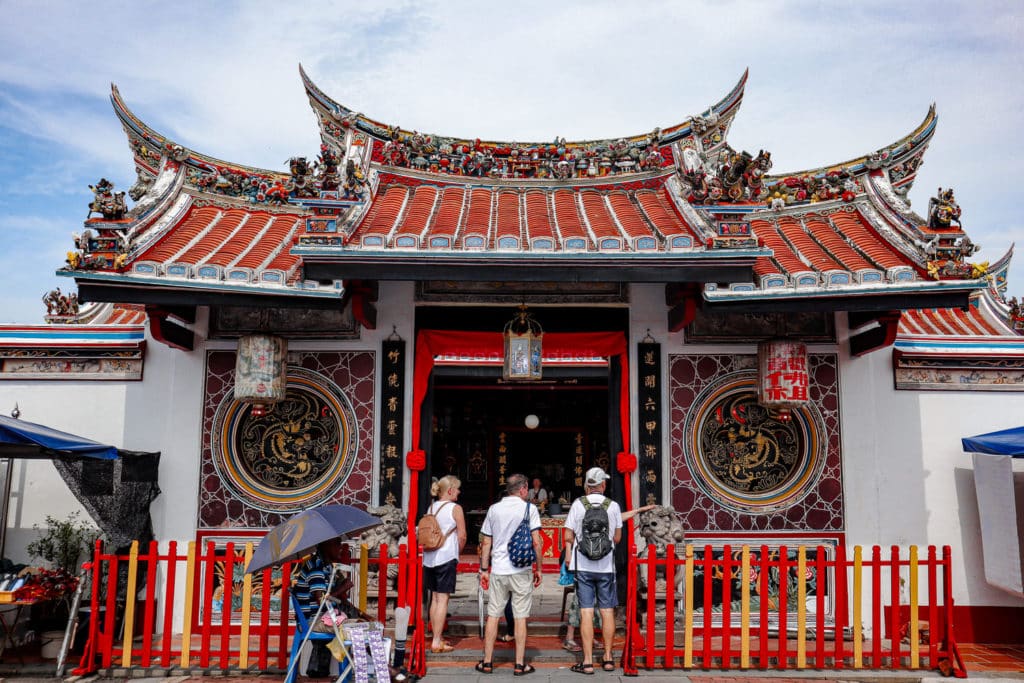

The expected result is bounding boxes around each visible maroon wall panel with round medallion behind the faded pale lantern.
[198,351,376,529]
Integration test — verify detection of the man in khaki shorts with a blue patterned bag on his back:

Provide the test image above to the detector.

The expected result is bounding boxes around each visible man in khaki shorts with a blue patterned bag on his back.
[476,474,541,676]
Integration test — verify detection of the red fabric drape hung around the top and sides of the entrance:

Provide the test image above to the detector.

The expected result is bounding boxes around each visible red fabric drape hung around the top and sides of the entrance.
[407,330,632,543]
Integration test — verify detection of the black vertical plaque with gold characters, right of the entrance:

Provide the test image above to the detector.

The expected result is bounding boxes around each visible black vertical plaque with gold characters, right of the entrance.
[637,343,662,505]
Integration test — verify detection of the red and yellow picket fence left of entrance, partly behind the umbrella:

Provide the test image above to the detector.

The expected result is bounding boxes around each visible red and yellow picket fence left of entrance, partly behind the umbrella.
[74,542,426,676]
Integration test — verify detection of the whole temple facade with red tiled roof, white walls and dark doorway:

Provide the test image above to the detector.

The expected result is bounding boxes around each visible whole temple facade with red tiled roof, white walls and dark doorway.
[0,73,1024,640]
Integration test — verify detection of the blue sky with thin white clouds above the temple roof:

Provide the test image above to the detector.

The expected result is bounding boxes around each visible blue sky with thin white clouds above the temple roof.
[0,0,1024,323]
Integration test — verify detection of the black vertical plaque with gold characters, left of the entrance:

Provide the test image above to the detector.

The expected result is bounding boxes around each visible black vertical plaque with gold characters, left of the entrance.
[377,339,406,507]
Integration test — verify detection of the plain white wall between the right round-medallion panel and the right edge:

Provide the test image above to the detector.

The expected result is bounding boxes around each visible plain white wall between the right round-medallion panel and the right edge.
[842,339,1024,606]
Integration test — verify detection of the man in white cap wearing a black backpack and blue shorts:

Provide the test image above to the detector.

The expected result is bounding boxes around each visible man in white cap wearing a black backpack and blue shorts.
[565,467,623,674]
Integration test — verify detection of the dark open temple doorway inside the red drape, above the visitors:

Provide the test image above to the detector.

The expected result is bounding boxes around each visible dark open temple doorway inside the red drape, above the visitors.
[428,368,606,562]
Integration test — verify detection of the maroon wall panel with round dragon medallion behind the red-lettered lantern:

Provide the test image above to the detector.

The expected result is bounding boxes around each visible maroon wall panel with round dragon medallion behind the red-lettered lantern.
[668,353,845,532]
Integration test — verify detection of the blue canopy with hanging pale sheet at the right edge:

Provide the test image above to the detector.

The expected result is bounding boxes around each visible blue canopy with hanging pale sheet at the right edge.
[961,427,1024,598]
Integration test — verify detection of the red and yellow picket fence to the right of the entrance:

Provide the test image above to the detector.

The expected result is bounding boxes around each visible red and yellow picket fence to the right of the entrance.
[624,546,966,677]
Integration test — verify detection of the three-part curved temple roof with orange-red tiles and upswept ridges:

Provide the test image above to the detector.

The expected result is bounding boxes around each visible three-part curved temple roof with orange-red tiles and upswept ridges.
[59,68,983,315]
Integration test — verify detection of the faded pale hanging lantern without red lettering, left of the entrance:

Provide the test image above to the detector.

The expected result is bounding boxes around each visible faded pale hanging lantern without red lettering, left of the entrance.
[234,335,288,417]
